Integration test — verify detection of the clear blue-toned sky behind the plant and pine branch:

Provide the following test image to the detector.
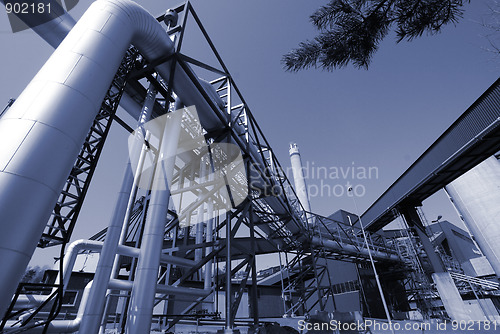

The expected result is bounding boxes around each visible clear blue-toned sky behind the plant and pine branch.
[0,0,500,264]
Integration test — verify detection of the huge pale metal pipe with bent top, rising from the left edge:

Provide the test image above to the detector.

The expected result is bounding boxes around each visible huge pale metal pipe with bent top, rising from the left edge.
[0,0,186,314]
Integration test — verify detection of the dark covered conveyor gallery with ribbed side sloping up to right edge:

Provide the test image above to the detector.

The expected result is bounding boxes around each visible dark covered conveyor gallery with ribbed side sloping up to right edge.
[362,79,500,231]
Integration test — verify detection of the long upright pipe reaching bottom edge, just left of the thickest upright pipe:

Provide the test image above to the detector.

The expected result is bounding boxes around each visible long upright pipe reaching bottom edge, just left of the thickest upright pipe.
[81,84,156,333]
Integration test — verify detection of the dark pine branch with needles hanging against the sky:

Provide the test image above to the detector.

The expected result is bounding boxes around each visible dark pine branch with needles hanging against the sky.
[282,0,470,72]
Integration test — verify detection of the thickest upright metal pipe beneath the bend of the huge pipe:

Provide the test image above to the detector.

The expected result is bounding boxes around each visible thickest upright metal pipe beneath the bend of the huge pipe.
[127,110,184,334]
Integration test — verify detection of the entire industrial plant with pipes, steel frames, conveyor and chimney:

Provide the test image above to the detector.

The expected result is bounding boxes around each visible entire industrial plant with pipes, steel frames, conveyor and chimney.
[0,0,500,334]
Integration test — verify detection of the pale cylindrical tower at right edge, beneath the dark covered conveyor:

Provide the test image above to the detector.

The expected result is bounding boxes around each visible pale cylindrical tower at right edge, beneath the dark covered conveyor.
[446,156,500,277]
